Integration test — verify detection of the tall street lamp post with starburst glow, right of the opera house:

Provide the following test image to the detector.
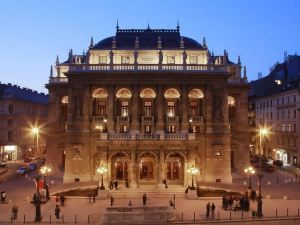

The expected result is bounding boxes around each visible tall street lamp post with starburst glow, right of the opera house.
[256,128,269,217]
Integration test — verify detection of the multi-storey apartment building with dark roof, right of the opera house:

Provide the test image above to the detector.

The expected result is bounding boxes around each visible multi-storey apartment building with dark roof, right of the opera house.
[249,55,300,166]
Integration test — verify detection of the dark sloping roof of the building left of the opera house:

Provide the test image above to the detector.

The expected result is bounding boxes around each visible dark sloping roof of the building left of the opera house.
[0,83,48,104]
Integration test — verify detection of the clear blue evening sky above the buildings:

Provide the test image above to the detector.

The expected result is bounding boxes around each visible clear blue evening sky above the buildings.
[0,0,300,92]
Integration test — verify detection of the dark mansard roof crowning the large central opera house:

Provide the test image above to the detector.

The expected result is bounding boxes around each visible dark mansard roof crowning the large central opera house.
[91,27,206,50]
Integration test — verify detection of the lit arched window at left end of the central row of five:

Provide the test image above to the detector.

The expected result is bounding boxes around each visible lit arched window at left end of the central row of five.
[92,88,108,116]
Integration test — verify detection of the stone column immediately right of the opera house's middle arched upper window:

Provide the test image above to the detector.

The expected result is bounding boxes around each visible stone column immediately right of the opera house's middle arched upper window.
[156,86,164,136]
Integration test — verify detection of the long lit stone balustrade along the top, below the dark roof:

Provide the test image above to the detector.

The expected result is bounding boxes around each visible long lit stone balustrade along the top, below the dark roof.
[69,64,229,72]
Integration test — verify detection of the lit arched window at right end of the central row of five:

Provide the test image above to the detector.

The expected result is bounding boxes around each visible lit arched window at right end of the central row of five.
[188,88,204,118]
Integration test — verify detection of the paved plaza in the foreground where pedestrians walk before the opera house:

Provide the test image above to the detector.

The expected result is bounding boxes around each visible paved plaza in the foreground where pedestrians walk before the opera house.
[0,168,300,224]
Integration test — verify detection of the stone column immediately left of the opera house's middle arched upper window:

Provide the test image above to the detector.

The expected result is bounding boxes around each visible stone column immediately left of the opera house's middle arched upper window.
[130,86,140,135]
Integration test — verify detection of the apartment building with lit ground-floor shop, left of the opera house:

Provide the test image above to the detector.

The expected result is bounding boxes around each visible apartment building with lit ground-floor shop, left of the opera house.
[0,83,48,161]
